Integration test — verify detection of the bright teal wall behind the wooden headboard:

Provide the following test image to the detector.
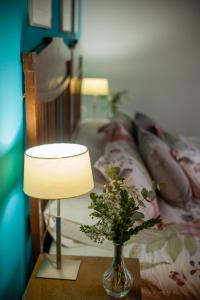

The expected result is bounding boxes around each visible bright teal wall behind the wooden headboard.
[0,0,79,300]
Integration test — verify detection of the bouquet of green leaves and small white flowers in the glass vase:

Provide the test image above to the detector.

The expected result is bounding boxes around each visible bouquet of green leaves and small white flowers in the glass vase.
[80,167,161,245]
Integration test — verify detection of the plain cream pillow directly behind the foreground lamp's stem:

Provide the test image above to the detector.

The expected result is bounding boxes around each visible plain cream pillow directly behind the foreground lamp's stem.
[44,188,112,249]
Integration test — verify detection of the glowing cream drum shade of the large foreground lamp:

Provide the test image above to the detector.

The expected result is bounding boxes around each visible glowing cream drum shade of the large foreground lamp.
[24,143,94,200]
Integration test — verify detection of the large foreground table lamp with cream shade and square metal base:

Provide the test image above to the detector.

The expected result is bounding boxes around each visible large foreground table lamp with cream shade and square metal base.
[24,143,94,280]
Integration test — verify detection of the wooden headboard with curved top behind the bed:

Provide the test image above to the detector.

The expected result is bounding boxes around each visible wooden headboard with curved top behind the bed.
[23,38,82,260]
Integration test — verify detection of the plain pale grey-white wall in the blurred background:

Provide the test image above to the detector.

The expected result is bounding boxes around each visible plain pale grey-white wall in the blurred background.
[82,0,200,136]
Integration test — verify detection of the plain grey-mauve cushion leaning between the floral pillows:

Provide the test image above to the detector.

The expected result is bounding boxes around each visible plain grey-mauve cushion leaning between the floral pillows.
[138,128,192,207]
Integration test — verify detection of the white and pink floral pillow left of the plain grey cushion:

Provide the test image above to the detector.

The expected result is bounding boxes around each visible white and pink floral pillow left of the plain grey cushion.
[94,124,159,220]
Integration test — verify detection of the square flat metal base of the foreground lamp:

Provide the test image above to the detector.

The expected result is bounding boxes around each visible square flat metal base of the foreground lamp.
[36,255,81,280]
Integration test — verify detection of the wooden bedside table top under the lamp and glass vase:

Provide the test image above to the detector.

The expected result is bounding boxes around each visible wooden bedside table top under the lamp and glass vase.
[22,255,141,300]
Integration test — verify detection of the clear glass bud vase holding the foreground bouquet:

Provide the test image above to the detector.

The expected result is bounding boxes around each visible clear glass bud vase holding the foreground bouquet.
[103,244,133,298]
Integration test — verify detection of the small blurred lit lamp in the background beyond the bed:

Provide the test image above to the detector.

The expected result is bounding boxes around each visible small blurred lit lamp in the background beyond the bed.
[81,78,109,118]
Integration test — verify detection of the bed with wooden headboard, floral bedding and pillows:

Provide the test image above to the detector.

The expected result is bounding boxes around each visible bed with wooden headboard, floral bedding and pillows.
[24,40,200,300]
